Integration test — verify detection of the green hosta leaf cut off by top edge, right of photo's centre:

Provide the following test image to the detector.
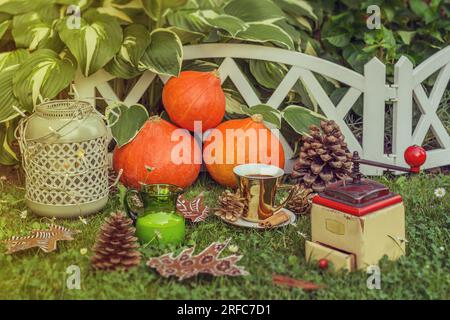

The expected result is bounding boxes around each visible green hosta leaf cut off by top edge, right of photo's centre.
[224,0,284,22]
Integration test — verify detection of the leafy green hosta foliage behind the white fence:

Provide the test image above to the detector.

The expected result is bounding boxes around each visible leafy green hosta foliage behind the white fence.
[0,0,450,159]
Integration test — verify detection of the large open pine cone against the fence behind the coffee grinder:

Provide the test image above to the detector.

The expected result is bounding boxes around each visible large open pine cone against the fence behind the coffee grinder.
[292,120,352,192]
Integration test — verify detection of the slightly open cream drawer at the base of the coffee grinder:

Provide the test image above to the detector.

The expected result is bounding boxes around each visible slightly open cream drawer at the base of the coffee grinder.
[305,241,356,271]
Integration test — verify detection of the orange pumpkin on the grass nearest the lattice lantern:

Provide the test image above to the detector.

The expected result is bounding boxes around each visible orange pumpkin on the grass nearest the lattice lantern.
[113,117,201,189]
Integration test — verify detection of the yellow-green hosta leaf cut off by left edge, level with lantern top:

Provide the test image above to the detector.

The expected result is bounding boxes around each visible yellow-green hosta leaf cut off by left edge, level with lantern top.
[0,49,29,123]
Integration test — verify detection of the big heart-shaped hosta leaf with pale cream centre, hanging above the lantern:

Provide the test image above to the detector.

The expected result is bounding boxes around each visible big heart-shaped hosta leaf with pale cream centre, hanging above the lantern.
[58,10,122,77]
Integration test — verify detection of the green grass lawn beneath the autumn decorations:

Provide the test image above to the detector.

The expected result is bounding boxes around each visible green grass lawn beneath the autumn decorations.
[0,174,450,299]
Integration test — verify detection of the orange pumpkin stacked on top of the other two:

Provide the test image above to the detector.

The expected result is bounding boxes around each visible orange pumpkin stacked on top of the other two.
[162,71,225,132]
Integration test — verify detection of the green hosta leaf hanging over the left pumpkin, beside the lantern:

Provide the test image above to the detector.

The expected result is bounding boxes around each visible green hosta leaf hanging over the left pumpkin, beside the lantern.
[106,104,148,148]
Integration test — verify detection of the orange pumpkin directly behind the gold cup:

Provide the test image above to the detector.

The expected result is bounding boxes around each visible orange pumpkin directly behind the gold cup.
[203,114,285,188]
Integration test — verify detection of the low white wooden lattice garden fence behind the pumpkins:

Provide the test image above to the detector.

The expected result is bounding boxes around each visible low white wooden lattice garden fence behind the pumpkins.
[75,44,450,175]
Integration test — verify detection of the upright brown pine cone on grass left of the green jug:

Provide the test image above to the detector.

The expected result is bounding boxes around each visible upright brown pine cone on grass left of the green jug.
[91,212,141,270]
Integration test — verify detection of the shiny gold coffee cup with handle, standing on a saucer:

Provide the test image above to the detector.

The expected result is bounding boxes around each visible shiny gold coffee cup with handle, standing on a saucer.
[233,163,294,222]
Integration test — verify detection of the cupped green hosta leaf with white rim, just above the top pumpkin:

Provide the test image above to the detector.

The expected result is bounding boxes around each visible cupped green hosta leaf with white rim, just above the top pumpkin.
[139,29,183,77]
